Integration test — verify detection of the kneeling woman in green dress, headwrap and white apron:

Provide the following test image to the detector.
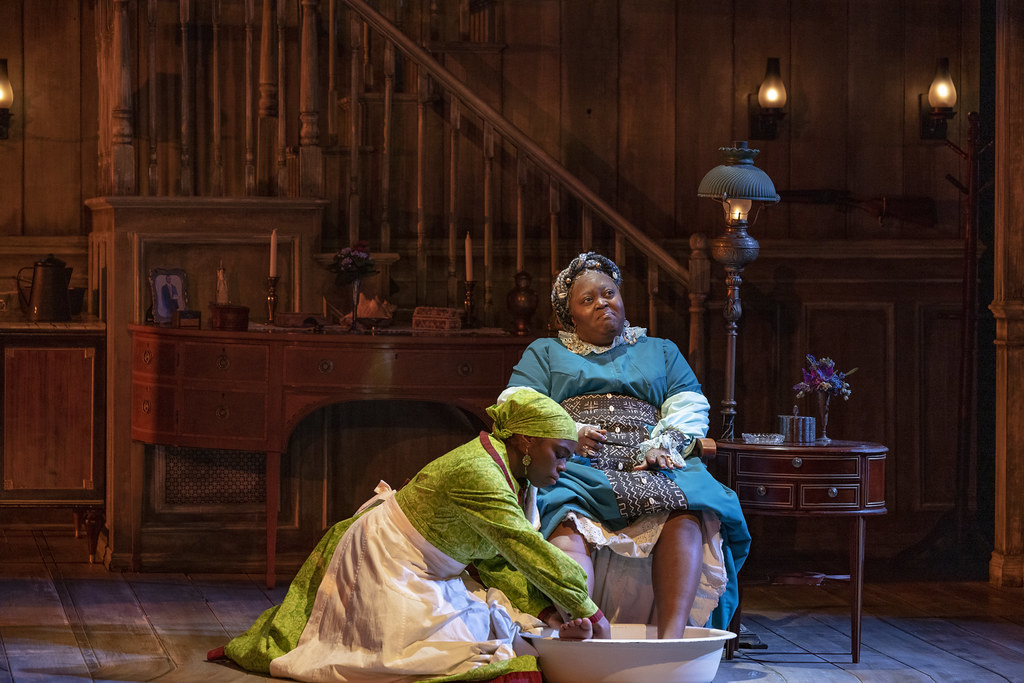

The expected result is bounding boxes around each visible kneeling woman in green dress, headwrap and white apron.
[210,391,609,682]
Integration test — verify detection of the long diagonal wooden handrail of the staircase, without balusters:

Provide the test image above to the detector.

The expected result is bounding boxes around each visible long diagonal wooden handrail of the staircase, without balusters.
[341,0,690,287]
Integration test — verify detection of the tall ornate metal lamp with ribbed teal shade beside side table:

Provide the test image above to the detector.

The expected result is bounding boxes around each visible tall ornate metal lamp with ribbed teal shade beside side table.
[697,140,779,438]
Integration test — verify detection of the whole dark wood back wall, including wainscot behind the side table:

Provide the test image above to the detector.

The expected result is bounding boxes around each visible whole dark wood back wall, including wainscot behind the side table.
[0,0,981,577]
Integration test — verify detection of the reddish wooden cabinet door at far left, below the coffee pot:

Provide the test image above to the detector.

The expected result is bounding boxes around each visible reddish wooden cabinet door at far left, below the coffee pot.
[3,346,101,500]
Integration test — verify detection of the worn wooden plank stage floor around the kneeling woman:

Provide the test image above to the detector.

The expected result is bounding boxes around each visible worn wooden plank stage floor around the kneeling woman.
[0,529,1024,683]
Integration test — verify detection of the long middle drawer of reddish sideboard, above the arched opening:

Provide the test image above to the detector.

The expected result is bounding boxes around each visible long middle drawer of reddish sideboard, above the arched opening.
[285,347,508,389]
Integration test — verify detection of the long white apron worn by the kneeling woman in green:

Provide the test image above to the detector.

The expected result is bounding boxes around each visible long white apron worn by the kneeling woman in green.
[270,493,541,682]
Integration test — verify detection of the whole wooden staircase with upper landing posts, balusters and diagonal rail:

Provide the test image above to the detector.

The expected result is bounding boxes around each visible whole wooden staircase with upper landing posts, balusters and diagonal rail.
[96,0,711,376]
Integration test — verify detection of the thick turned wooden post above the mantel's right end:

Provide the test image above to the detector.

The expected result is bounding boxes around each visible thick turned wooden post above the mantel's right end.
[299,0,324,197]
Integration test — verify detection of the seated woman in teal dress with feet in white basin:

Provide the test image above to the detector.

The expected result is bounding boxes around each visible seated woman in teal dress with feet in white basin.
[499,252,751,638]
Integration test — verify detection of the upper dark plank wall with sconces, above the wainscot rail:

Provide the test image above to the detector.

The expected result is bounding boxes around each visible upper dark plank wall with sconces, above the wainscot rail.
[0,0,979,239]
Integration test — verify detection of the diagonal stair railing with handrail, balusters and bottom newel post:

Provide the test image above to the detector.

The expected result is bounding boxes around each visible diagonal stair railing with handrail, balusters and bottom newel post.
[341,0,711,376]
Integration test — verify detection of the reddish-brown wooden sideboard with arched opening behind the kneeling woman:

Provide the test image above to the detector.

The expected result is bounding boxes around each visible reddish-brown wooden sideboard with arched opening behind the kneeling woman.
[130,326,530,586]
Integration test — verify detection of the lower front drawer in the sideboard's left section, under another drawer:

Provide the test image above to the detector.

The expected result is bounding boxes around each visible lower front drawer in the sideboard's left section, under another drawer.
[179,389,267,440]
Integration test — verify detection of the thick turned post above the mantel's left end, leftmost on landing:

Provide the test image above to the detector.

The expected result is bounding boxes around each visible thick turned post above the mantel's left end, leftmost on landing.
[111,0,135,195]
